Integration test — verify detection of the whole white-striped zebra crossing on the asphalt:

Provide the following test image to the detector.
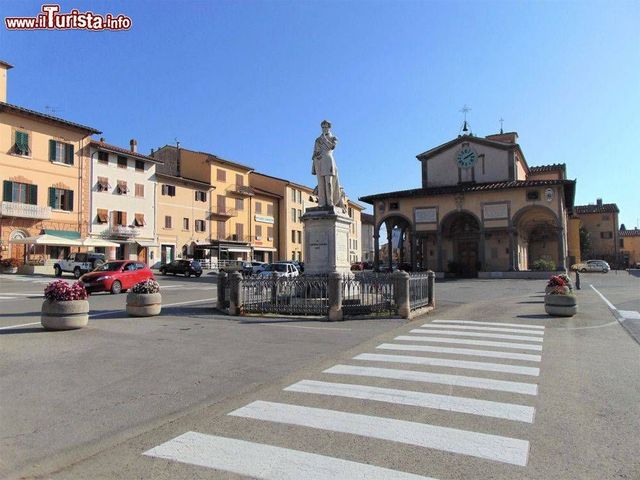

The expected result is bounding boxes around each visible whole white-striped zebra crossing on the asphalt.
[144,319,545,480]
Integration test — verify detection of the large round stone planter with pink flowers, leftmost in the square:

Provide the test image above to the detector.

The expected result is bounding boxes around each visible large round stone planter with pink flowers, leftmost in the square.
[40,280,89,330]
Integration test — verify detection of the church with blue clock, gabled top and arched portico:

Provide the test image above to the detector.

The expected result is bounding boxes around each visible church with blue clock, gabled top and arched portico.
[360,132,576,276]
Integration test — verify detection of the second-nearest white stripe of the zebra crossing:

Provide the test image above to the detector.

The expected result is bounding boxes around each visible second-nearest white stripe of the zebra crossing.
[229,400,529,464]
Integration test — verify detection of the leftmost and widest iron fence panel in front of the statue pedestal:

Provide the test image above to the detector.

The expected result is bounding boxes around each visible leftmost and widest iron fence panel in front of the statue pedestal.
[241,275,329,316]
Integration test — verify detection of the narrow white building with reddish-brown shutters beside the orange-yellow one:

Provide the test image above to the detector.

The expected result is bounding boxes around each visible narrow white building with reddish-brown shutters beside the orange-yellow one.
[89,139,161,265]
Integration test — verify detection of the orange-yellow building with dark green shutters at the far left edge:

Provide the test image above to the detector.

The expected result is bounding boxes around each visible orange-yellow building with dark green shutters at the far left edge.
[0,61,101,262]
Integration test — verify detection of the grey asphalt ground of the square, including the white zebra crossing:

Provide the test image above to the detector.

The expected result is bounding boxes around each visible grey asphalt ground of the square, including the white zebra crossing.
[0,273,640,480]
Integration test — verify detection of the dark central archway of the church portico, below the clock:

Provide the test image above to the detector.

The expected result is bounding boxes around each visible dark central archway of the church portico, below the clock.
[436,210,484,277]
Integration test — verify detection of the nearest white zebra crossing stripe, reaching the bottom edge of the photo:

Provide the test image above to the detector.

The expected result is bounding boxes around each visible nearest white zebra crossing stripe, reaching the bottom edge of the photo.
[143,432,435,480]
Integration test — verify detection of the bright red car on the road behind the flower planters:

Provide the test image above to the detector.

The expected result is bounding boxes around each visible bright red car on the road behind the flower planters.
[80,260,155,293]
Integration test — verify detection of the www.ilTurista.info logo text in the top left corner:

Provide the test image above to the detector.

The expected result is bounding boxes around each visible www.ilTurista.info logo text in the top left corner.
[4,4,132,32]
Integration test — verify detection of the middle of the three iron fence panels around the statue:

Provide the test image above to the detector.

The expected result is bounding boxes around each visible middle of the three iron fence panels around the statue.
[342,273,398,316]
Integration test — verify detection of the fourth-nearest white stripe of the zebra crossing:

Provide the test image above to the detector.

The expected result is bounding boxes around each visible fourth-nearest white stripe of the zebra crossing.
[322,365,538,396]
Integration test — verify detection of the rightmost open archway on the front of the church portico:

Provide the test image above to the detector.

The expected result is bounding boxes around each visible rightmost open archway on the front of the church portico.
[512,205,566,270]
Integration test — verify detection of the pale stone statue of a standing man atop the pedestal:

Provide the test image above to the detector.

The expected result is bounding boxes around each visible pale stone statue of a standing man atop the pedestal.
[311,120,341,207]
